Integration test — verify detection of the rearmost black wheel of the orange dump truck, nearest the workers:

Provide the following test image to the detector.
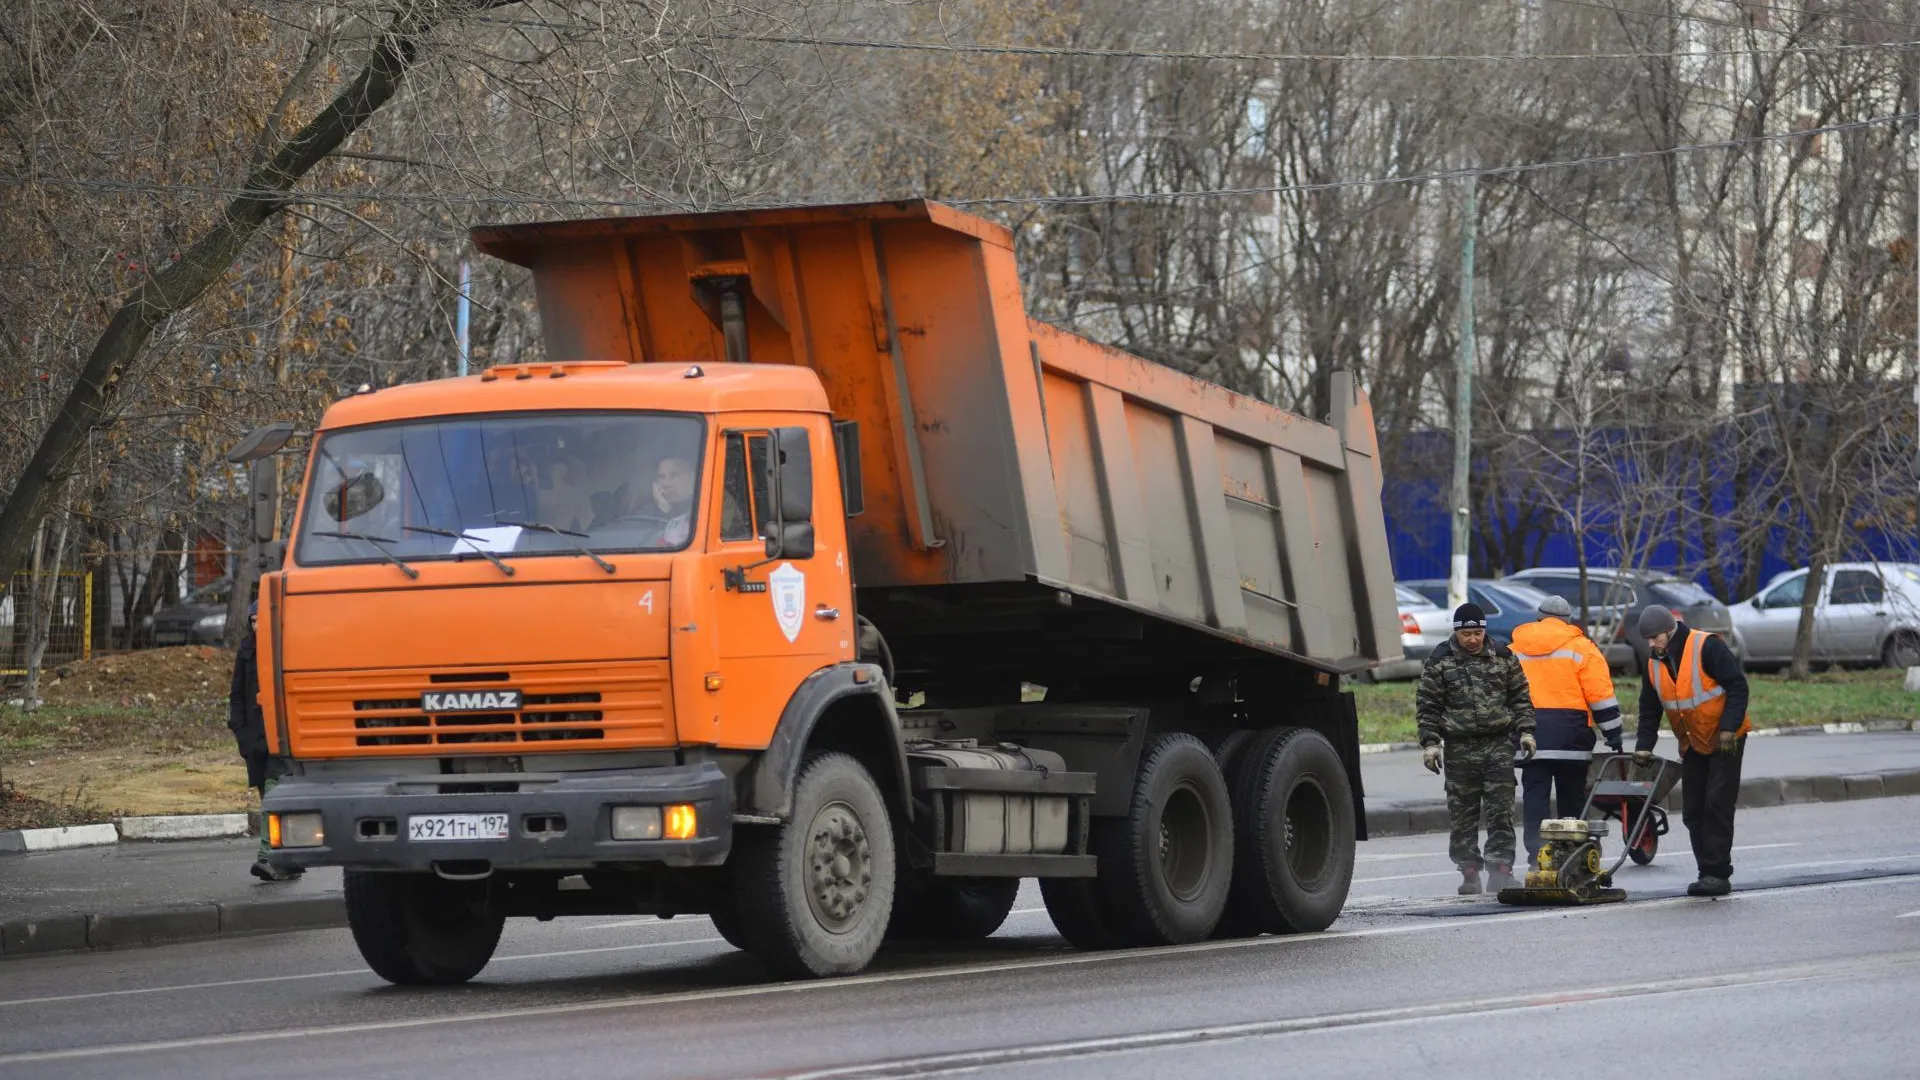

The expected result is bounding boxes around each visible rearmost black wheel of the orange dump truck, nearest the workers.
[1227,728,1354,934]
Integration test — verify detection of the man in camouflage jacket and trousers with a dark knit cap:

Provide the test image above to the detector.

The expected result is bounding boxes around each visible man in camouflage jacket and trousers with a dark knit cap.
[1415,603,1534,896]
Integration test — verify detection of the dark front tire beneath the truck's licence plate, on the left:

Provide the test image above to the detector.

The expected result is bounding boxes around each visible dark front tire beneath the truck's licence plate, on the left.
[342,871,507,986]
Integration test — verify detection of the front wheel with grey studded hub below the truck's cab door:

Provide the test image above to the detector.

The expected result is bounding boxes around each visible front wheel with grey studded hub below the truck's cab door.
[732,751,895,978]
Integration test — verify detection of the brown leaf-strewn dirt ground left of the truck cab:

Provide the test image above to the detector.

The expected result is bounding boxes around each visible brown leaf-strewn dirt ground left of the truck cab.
[0,646,253,828]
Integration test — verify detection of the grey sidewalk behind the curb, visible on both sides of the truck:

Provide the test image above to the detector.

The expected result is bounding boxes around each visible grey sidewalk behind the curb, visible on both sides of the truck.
[11,732,1920,963]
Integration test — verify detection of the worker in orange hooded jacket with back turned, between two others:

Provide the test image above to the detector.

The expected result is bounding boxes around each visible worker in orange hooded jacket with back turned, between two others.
[1511,596,1622,865]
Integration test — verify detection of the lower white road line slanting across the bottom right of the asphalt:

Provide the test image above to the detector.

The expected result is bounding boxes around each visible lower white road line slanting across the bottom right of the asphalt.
[781,953,1920,1080]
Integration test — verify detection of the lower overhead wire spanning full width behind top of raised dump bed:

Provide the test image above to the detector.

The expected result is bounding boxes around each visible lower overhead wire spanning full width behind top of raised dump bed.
[0,111,1920,213]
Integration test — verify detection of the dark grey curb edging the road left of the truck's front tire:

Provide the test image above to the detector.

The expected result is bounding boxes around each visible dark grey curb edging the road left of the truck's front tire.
[0,894,348,959]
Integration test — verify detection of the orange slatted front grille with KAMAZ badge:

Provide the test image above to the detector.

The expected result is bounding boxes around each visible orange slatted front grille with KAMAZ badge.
[286,661,674,757]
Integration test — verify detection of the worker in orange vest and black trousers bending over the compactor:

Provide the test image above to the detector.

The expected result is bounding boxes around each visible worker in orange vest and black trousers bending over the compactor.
[1634,603,1753,896]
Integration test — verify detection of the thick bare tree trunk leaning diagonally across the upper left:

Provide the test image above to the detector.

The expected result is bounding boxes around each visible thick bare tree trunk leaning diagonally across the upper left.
[0,0,478,595]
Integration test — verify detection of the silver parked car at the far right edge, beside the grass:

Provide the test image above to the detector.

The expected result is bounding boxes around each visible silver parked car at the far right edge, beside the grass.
[1734,563,1920,669]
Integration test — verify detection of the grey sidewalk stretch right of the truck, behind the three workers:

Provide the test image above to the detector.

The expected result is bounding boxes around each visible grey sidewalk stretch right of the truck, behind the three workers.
[1359,732,1920,836]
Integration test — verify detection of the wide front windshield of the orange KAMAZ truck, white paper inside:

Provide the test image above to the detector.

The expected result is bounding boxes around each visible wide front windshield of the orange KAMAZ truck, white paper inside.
[294,413,703,565]
